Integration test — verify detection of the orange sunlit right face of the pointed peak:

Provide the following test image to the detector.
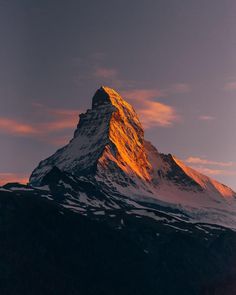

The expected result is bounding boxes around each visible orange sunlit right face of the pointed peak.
[92,86,151,180]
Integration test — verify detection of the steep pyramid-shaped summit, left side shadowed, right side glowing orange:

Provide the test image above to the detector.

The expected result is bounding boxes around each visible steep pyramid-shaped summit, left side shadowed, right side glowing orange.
[30,87,152,185]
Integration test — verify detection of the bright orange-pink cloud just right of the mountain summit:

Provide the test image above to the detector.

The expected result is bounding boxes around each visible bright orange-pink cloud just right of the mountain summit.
[122,89,179,129]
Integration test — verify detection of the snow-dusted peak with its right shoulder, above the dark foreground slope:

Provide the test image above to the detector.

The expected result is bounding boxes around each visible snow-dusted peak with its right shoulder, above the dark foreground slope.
[30,87,236,228]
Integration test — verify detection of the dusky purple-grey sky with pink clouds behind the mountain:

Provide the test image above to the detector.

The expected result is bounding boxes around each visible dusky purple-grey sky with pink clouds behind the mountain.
[0,0,236,190]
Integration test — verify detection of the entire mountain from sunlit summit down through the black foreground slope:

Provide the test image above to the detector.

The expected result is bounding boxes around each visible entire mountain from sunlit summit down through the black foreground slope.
[0,87,236,295]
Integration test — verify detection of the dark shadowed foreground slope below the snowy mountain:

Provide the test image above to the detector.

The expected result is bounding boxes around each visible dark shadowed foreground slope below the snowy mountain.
[0,185,236,295]
